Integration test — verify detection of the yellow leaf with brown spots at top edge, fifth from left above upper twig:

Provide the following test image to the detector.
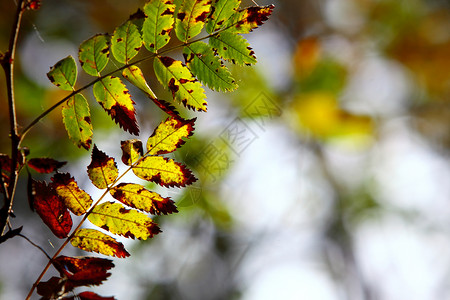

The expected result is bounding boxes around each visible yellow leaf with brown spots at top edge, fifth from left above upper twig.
[175,0,211,42]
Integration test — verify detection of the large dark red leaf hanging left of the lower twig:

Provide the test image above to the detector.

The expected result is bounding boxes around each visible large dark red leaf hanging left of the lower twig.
[33,181,72,239]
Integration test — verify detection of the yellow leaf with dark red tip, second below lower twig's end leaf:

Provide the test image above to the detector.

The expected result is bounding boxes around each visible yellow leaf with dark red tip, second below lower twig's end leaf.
[110,183,178,215]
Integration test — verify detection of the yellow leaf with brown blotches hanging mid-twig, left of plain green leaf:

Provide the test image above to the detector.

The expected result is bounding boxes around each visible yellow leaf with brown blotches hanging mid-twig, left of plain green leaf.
[153,56,207,111]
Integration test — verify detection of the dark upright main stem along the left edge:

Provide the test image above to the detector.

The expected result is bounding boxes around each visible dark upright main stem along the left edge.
[0,0,25,235]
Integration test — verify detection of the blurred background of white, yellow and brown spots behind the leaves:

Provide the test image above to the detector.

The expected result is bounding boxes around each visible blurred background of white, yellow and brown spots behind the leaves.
[0,0,450,300]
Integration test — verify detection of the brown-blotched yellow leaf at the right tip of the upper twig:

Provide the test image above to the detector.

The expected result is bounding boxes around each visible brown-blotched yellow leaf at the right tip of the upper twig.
[226,4,275,33]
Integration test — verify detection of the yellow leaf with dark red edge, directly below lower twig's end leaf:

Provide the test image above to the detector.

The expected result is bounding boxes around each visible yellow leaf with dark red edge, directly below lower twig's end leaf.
[133,156,197,187]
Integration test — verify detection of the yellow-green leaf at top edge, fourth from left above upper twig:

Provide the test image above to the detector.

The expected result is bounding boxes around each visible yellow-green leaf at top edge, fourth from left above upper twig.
[142,0,175,53]
